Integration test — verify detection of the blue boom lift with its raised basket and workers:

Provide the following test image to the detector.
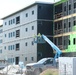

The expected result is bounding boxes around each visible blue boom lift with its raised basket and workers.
[34,33,62,59]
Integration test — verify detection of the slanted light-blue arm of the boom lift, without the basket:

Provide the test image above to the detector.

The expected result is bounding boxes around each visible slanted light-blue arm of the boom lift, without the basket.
[35,34,62,59]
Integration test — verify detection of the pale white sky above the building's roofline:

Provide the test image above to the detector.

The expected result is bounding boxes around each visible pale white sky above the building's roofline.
[0,0,59,23]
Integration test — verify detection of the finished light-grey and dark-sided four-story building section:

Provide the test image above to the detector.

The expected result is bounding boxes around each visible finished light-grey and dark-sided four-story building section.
[1,2,53,64]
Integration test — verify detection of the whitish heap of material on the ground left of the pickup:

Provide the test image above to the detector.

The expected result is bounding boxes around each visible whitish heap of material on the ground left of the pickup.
[0,65,26,75]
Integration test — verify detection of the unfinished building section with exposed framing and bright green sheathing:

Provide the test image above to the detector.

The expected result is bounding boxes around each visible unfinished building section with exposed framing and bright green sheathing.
[53,0,76,56]
